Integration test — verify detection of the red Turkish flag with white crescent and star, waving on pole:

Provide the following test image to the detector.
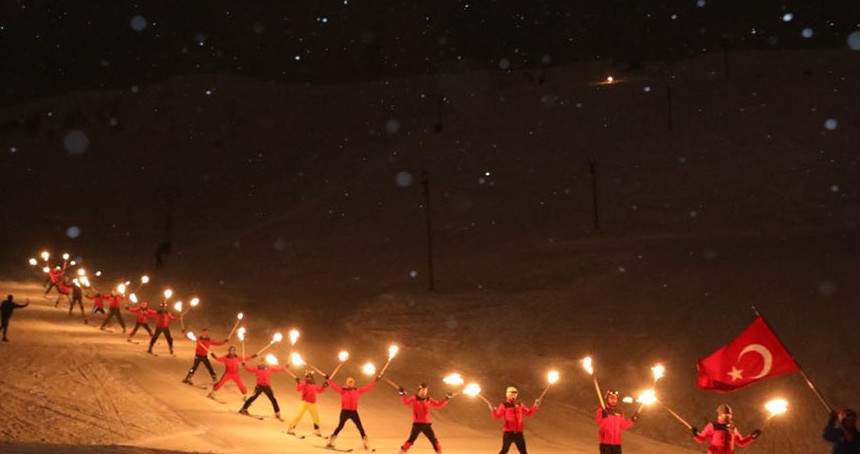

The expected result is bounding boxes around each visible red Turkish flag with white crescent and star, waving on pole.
[696,317,800,392]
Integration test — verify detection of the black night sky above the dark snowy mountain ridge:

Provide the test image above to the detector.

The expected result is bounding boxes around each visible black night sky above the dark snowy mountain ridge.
[0,0,860,103]
